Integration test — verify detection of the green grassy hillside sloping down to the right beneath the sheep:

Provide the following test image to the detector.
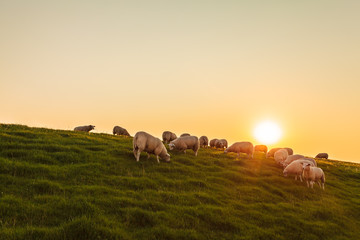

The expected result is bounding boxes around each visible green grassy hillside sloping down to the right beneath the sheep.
[0,124,360,240]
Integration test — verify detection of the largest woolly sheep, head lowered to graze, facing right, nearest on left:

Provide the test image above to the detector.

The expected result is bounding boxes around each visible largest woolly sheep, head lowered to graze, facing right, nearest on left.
[133,131,170,163]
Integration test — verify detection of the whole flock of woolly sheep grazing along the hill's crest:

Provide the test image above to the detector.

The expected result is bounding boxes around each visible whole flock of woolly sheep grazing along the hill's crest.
[74,125,328,189]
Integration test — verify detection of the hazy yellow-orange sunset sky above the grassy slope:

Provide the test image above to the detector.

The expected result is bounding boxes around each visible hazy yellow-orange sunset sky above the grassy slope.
[0,0,360,162]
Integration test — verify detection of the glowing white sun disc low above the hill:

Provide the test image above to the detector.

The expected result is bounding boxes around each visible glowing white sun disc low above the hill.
[254,121,282,144]
